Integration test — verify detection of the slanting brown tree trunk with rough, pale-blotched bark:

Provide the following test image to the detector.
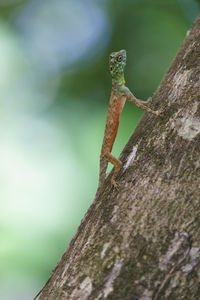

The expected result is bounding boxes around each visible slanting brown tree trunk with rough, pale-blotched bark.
[39,18,200,300]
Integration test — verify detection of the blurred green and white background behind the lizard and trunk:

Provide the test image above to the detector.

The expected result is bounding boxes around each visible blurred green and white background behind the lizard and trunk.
[0,0,200,300]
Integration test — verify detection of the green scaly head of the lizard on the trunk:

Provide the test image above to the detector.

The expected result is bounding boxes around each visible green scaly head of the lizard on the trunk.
[109,50,126,85]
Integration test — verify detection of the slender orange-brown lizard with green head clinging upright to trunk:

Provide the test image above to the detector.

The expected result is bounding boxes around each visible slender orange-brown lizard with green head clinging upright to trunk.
[96,50,161,195]
